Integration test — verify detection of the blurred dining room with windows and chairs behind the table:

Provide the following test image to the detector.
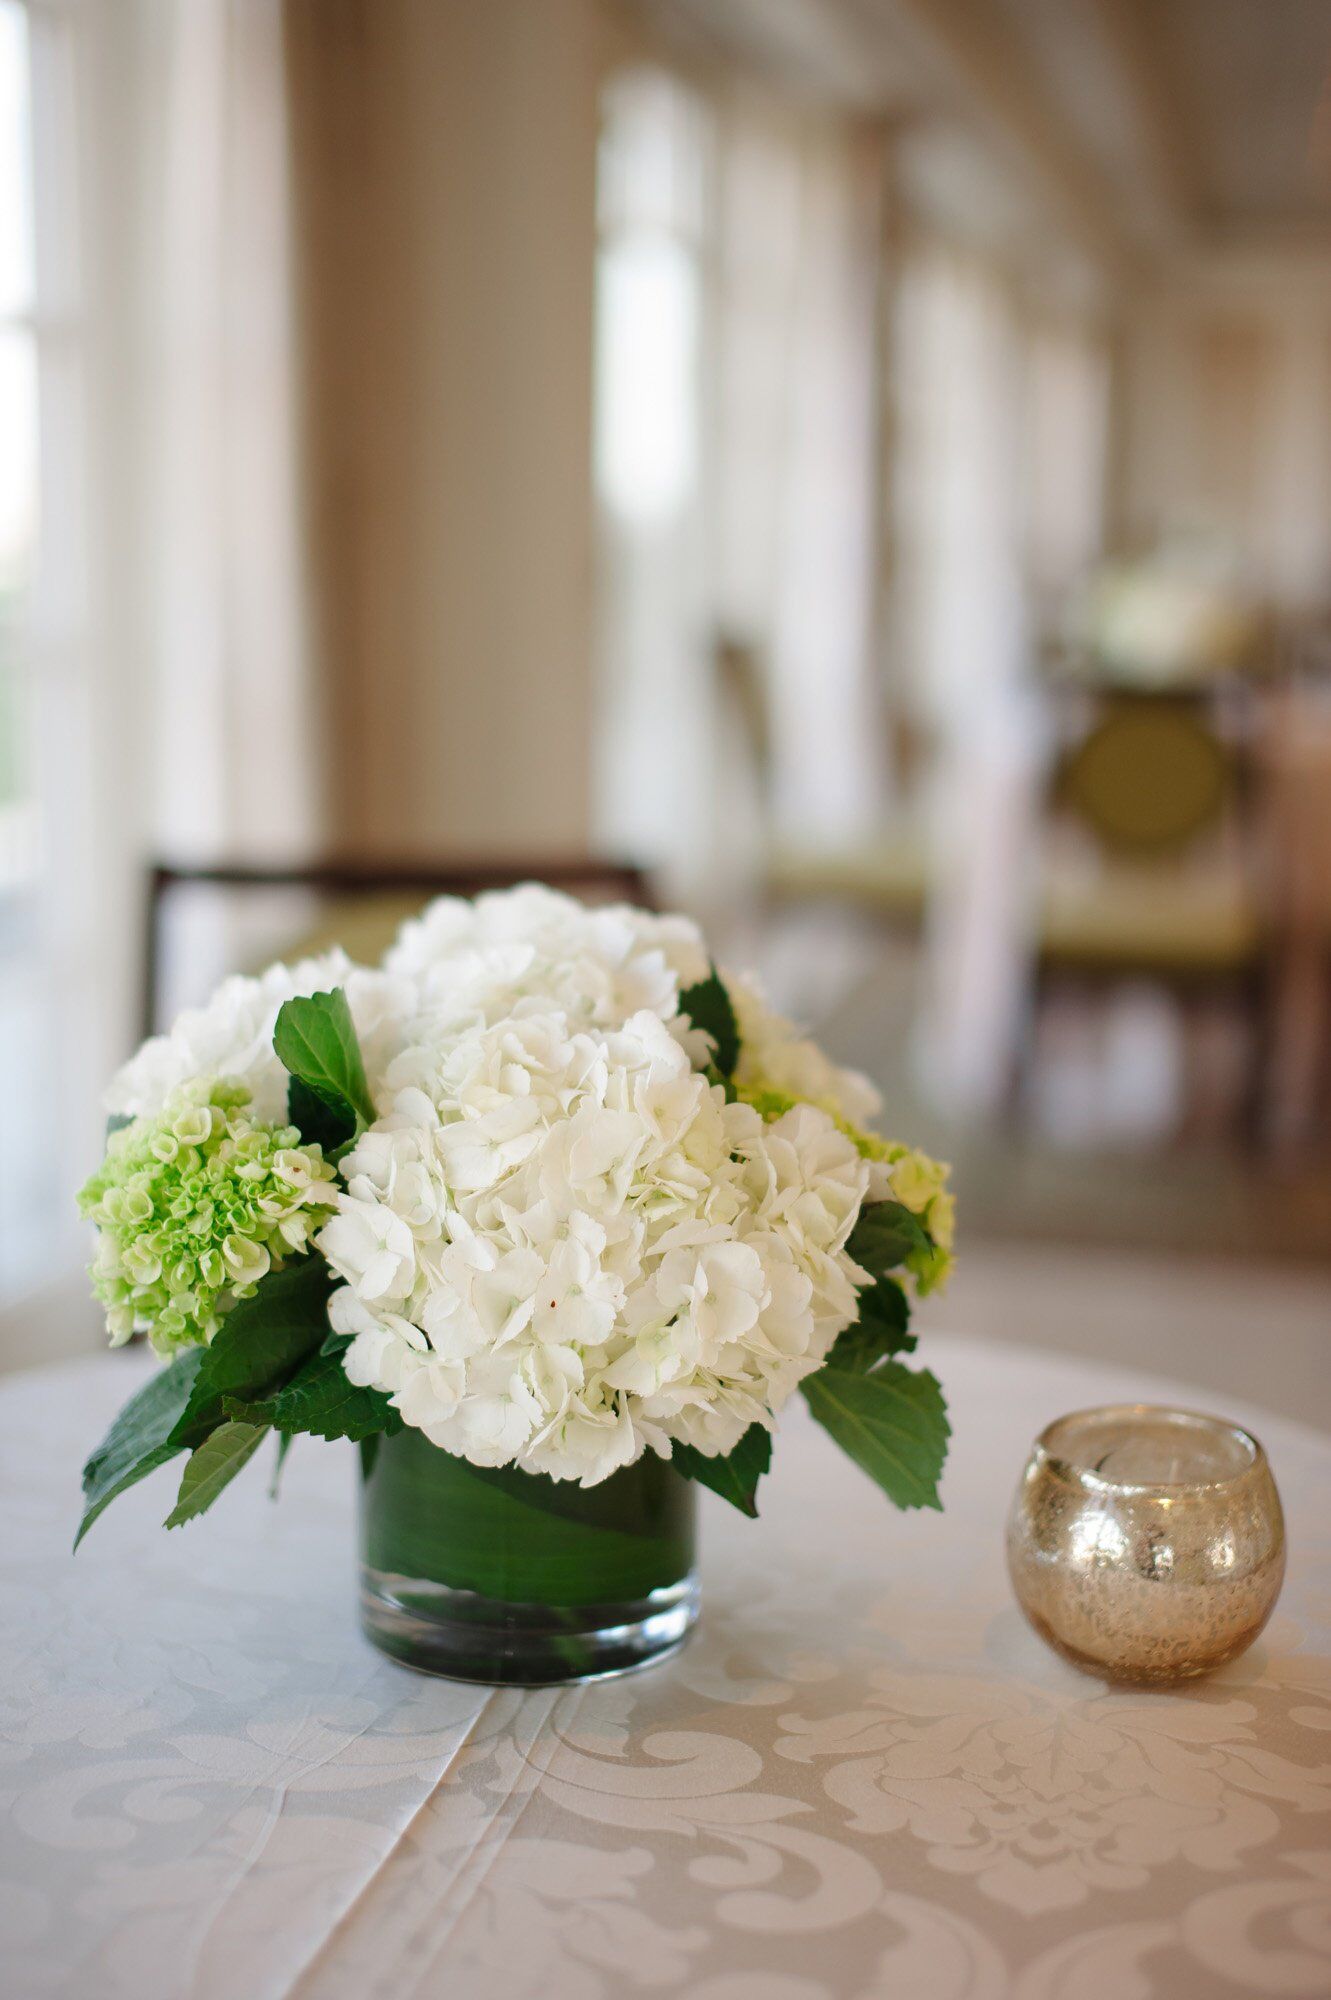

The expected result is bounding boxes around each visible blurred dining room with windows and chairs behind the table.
[0,0,1331,1424]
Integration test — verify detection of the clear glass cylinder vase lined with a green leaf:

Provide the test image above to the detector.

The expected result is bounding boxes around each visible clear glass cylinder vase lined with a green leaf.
[360,1426,697,1686]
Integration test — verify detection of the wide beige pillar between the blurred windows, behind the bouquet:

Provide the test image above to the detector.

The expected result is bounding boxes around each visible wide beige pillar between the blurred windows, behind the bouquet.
[290,0,604,856]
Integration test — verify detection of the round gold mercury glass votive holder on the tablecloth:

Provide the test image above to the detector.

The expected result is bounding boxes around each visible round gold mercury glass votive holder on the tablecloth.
[1007,1404,1285,1682]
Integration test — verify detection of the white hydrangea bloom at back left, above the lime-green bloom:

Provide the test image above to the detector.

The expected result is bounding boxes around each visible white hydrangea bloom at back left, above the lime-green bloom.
[104,950,416,1124]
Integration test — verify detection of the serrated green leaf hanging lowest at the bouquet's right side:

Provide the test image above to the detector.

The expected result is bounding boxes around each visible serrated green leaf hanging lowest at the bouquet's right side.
[799,1362,951,1508]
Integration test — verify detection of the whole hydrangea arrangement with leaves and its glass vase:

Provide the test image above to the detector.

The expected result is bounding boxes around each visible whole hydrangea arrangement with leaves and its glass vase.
[76,886,953,1682]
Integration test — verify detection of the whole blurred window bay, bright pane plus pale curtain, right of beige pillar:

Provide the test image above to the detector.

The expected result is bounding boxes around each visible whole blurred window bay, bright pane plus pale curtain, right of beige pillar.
[596,66,887,902]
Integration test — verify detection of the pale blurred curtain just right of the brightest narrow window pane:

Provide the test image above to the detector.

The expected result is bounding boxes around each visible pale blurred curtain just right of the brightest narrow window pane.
[707,105,893,850]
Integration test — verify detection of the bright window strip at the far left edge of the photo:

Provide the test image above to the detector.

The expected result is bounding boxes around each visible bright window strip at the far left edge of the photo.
[0,0,86,1296]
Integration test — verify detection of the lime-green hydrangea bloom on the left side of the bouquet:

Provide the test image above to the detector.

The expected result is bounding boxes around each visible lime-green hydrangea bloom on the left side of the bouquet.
[78,1078,336,1354]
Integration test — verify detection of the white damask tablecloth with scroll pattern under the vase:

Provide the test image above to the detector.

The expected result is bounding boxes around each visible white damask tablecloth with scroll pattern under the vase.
[0,1330,1331,2000]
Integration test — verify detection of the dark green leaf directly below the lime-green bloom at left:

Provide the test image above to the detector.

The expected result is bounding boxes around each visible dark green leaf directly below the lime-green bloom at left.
[172,1256,332,1446]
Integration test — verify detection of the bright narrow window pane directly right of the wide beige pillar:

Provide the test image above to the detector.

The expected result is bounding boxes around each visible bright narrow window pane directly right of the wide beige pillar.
[596,66,709,872]
